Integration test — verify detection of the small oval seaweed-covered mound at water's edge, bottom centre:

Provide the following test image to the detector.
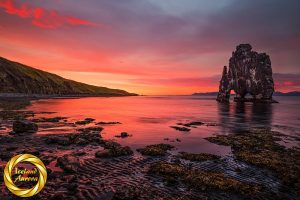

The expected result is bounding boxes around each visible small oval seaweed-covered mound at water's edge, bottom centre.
[137,144,174,156]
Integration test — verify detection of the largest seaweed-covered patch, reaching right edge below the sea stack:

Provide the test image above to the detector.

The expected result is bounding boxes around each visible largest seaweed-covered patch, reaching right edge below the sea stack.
[206,129,300,194]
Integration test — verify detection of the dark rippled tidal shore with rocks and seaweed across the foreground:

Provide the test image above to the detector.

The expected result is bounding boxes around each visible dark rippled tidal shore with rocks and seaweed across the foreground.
[0,98,299,200]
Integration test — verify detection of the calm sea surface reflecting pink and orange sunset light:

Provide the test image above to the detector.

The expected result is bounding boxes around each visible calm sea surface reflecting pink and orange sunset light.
[27,96,300,155]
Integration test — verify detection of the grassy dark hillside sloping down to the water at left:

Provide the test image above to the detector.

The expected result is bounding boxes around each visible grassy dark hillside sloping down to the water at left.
[0,57,135,96]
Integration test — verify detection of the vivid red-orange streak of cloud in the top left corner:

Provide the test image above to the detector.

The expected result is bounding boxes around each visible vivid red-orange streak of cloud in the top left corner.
[0,0,97,29]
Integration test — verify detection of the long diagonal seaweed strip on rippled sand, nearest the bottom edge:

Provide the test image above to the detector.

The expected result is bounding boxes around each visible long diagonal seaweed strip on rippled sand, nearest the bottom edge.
[149,161,261,196]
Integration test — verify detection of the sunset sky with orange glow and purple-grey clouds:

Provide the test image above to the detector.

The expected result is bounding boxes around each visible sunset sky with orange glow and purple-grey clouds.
[0,0,300,95]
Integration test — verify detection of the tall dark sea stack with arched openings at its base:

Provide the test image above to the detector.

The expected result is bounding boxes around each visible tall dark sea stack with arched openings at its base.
[217,44,276,103]
